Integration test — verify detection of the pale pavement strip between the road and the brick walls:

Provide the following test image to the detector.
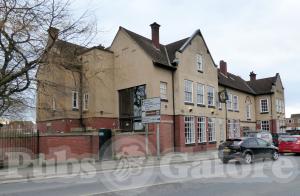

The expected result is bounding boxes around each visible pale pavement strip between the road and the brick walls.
[0,150,218,184]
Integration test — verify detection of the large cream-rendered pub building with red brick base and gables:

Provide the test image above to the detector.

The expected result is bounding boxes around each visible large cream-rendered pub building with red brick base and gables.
[37,23,284,152]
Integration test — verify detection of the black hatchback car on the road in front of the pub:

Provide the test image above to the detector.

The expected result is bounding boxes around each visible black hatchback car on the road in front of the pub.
[219,137,279,164]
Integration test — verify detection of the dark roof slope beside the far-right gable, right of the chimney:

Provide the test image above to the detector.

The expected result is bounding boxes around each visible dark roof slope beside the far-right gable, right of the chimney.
[247,75,277,95]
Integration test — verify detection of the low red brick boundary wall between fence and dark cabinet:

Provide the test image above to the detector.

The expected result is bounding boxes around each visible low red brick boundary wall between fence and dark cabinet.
[39,134,99,161]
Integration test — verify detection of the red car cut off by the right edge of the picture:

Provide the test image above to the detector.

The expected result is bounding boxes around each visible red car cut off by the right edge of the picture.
[278,135,300,154]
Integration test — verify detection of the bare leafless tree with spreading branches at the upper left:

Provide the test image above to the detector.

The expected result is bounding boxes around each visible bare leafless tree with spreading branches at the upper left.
[0,0,96,117]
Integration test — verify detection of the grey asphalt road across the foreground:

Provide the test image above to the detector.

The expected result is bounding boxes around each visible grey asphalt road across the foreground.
[0,155,300,196]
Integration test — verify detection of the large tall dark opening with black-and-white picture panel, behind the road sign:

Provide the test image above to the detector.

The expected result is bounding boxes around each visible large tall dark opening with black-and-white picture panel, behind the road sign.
[119,85,146,131]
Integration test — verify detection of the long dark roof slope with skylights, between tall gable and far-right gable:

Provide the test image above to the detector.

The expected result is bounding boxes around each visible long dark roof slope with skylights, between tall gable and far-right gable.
[218,69,256,94]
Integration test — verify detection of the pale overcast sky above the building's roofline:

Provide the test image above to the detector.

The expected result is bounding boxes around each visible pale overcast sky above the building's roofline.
[73,0,300,117]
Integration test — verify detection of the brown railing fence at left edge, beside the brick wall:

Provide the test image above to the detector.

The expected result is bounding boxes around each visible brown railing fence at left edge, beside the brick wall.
[0,126,39,166]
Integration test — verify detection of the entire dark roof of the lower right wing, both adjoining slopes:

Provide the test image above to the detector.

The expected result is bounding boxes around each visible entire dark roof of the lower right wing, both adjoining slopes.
[218,70,278,95]
